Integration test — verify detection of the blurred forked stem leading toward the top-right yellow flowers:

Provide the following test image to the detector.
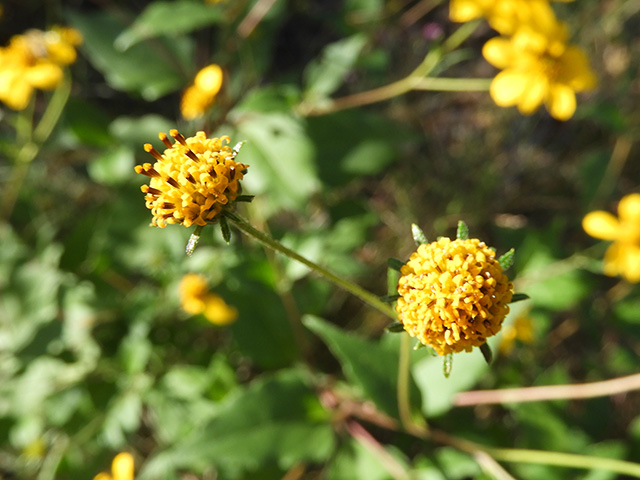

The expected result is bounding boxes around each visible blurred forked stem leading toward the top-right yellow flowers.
[299,21,486,116]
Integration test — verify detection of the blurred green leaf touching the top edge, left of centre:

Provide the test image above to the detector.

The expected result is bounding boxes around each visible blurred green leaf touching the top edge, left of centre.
[114,0,225,51]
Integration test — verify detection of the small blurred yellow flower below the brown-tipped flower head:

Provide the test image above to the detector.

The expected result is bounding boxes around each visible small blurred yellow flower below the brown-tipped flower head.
[179,273,238,326]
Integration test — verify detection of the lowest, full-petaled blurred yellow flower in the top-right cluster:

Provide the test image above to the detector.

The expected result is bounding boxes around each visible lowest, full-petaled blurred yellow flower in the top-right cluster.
[482,24,597,120]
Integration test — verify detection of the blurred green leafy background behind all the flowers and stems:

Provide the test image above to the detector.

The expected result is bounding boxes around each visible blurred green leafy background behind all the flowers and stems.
[0,0,640,480]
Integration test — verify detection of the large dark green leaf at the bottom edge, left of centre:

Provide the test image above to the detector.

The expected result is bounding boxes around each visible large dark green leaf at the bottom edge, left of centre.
[136,370,334,480]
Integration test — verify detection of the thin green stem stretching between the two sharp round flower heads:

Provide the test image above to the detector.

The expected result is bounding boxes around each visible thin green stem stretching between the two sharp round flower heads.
[224,211,397,320]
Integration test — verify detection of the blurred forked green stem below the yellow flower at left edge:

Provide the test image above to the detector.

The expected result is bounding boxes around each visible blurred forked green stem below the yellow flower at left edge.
[0,74,71,220]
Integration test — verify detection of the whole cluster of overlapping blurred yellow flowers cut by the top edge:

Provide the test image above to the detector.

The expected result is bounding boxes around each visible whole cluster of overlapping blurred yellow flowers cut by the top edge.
[450,0,597,120]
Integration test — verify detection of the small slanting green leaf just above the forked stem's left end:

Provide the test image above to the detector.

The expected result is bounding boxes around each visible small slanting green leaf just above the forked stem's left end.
[304,34,367,104]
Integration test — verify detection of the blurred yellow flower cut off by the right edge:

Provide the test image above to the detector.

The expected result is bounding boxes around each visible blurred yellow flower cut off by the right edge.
[582,193,640,283]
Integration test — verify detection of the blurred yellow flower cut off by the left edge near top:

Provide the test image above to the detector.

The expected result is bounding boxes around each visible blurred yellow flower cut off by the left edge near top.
[0,27,82,110]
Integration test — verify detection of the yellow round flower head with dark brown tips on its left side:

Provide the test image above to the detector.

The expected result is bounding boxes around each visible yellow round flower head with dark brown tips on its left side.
[135,130,248,227]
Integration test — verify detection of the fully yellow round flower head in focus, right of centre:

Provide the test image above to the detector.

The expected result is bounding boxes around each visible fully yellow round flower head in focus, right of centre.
[396,237,513,355]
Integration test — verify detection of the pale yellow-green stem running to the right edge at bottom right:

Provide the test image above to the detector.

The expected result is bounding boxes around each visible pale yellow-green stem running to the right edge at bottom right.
[482,447,640,478]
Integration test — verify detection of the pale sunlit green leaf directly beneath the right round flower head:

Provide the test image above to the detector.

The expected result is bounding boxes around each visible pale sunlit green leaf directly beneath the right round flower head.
[412,349,488,417]
